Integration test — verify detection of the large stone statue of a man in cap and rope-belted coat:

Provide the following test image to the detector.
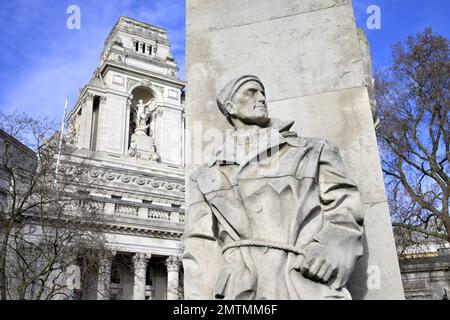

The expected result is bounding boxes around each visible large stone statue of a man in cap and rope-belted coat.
[182,75,363,299]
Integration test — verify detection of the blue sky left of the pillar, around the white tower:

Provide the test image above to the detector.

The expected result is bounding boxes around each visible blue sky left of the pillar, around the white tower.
[0,0,185,120]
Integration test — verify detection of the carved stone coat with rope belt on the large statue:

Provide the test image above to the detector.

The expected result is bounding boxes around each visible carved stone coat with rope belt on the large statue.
[183,119,363,299]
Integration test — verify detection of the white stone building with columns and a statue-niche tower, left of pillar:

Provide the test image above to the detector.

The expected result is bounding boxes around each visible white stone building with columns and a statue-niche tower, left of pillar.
[65,17,185,300]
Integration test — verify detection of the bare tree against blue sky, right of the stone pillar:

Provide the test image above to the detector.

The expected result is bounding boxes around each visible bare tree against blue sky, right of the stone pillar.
[376,28,450,252]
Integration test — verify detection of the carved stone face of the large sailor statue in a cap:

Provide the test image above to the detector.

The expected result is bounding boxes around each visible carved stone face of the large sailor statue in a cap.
[227,81,269,125]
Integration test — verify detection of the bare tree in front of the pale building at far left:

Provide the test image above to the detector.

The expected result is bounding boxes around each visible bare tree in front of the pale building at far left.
[0,113,104,300]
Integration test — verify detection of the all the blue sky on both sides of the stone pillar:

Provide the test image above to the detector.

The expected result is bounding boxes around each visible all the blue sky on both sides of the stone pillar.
[0,0,450,119]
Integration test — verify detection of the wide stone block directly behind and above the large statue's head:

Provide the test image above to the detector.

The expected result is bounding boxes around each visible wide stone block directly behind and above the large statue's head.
[186,1,364,113]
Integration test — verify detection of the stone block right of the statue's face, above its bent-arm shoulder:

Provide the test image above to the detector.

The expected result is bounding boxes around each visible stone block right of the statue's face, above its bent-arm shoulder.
[269,88,386,203]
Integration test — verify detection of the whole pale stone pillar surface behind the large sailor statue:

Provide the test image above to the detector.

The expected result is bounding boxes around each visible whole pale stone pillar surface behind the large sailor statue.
[186,0,404,299]
